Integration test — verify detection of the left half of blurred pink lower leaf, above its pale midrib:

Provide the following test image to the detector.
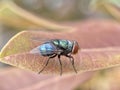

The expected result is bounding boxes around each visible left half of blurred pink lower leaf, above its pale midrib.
[0,68,54,90]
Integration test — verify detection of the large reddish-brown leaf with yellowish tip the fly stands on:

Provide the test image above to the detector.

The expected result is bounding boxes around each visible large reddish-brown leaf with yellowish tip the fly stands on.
[1,20,120,73]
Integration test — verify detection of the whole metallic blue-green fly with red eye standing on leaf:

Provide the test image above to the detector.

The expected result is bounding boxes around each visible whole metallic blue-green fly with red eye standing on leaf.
[31,39,79,75]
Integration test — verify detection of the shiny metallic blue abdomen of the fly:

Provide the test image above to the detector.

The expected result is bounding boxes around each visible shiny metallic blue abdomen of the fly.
[39,43,56,56]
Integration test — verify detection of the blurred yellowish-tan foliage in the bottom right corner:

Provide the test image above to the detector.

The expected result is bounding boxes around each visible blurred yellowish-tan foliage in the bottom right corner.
[77,67,120,90]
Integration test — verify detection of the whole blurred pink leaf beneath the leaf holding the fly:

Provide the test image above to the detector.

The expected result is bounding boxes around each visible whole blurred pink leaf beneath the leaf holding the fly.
[0,68,94,90]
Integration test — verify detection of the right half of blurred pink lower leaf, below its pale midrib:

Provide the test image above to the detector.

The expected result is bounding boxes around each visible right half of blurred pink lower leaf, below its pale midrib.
[19,72,93,90]
